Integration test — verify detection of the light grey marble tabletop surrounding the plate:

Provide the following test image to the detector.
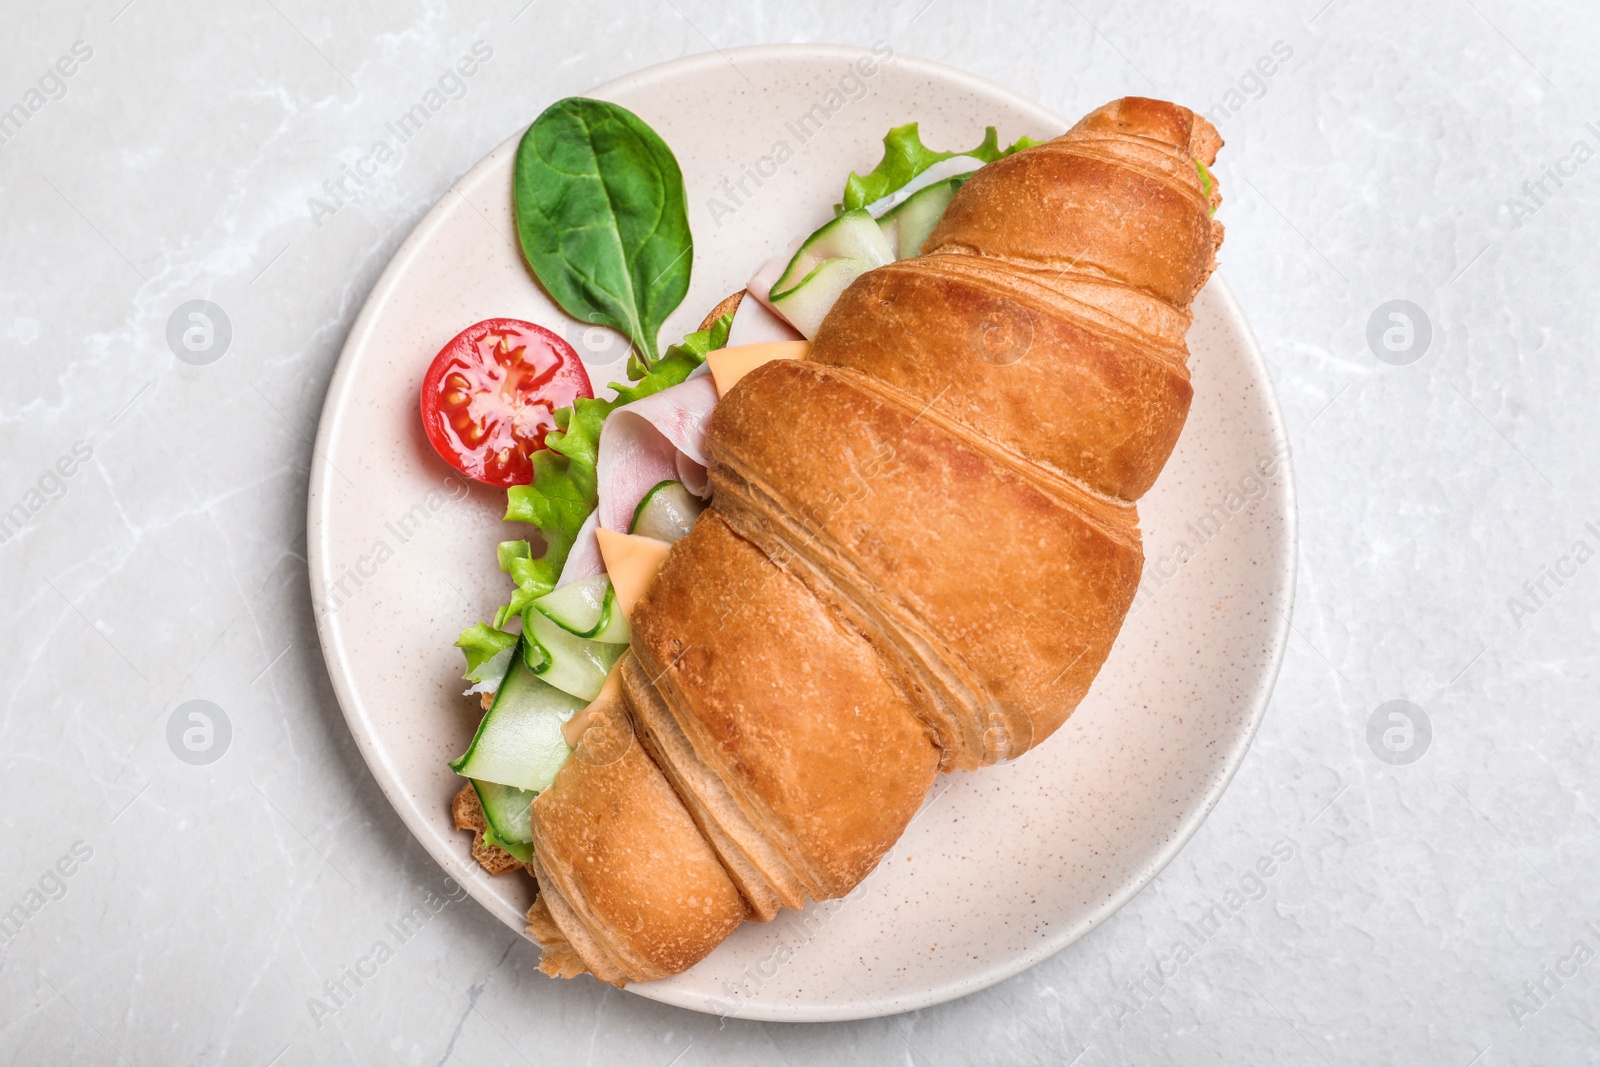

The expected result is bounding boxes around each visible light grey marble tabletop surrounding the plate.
[0,0,1600,1067]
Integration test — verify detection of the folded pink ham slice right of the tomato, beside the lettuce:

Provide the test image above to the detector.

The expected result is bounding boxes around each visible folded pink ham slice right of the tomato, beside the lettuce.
[595,374,717,533]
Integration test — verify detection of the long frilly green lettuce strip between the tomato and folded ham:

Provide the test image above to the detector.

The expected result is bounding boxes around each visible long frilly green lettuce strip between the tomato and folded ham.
[462,315,733,652]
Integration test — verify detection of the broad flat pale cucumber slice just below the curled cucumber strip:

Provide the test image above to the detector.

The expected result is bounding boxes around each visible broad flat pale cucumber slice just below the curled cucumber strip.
[450,639,589,796]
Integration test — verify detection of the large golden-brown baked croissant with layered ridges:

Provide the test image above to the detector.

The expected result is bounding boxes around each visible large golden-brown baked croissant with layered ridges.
[528,98,1222,984]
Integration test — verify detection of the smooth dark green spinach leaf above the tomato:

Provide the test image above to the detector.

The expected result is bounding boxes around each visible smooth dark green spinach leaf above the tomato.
[512,96,694,370]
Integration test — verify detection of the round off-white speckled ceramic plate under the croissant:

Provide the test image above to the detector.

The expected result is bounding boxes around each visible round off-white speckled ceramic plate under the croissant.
[307,45,1294,1021]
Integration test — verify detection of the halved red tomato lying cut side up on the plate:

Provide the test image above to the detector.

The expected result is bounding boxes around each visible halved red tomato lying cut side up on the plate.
[421,318,595,490]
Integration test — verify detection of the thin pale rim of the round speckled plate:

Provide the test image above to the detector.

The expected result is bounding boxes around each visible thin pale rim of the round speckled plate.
[306,45,1299,1022]
